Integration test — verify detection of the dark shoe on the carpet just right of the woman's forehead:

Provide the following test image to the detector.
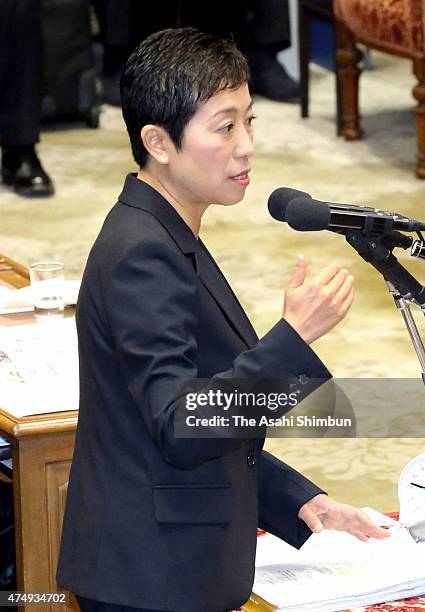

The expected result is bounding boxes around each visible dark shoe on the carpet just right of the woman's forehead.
[249,51,300,102]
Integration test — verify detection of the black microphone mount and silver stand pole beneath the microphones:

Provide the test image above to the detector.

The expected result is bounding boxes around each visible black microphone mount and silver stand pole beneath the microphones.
[343,229,425,385]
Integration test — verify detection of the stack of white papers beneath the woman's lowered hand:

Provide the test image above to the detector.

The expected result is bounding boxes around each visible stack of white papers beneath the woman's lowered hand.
[253,506,425,612]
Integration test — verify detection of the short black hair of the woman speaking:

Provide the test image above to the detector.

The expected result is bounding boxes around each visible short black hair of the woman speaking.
[120,28,250,167]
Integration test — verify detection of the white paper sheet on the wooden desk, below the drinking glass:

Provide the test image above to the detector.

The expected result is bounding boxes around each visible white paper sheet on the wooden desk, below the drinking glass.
[0,317,79,417]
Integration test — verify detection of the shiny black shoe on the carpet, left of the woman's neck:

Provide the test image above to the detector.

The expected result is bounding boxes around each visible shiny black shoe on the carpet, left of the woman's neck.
[1,146,55,198]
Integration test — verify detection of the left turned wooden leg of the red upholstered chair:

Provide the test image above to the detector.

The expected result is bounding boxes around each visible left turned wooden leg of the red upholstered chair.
[335,20,363,140]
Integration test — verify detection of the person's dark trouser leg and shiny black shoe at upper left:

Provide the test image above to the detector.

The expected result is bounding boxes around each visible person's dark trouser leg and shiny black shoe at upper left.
[0,0,54,197]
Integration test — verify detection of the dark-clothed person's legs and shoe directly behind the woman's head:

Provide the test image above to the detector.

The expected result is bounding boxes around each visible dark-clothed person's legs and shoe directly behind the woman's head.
[92,0,299,106]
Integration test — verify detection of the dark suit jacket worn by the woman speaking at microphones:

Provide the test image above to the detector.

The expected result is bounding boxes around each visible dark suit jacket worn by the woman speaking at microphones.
[57,175,330,612]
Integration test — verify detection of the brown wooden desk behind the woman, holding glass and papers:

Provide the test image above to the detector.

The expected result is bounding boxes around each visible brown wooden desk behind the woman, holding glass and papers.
[0,254,79,612]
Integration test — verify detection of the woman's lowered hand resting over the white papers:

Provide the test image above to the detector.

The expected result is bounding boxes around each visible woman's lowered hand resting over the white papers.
[298,493,390,542]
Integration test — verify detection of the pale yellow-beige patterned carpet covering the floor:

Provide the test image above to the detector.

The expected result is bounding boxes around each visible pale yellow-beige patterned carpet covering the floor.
[0,54,425,511]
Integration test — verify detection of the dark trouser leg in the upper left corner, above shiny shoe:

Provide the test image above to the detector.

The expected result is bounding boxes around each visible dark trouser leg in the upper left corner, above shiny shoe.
[0,0,43,146]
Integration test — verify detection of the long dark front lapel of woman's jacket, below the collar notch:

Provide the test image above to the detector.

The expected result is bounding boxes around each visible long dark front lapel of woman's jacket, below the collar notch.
[195,240,258,348]
